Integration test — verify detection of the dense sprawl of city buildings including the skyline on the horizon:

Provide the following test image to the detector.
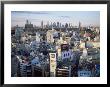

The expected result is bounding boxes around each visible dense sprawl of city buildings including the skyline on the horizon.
[11,20,100,77]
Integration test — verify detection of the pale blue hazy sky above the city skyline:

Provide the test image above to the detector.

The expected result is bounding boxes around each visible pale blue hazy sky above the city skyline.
[11,11,100,26]
